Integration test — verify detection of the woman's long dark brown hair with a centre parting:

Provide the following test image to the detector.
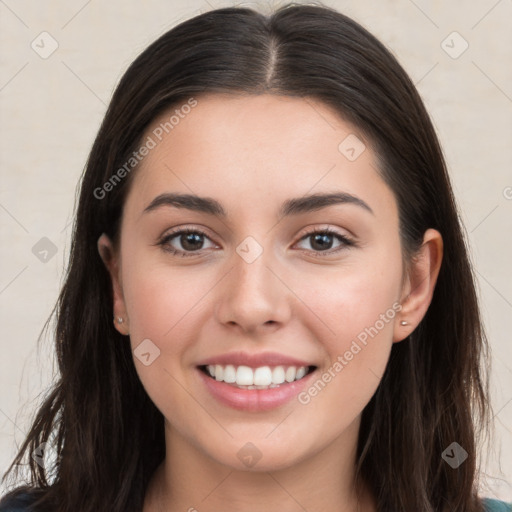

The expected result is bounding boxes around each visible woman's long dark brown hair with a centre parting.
[0,4,489,512]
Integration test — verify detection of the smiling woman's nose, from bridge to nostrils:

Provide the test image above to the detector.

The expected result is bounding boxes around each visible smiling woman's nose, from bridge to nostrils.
[216,245,293,333]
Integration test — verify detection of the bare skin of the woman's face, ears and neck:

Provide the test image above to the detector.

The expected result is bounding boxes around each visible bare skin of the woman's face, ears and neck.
[98,95,442,512]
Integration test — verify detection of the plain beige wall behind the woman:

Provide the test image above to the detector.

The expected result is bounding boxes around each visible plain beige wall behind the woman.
[0,0,512,500]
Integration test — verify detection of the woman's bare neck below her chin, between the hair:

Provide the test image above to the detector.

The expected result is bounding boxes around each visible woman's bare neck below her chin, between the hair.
[144,422,377,512]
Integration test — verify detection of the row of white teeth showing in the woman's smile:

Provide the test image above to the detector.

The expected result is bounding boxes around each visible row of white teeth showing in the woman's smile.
[198,364,316,390]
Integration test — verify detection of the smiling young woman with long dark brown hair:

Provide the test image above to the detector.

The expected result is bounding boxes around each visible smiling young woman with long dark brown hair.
[0,5,509,512]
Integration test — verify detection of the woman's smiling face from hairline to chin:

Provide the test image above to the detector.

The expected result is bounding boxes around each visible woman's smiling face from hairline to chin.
[100,95,410,470]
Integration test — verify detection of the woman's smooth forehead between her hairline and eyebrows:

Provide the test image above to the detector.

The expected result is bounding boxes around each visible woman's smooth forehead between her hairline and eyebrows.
[126,94,392,222]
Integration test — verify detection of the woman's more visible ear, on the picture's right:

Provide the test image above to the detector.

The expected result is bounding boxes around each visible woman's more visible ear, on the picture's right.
[393,229,443,342]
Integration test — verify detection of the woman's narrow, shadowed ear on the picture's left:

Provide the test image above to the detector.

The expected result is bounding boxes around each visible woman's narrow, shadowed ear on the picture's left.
[98,233,130,335]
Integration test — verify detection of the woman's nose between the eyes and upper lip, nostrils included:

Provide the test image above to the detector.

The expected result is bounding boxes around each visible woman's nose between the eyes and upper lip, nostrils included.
[217,237,289,330]
